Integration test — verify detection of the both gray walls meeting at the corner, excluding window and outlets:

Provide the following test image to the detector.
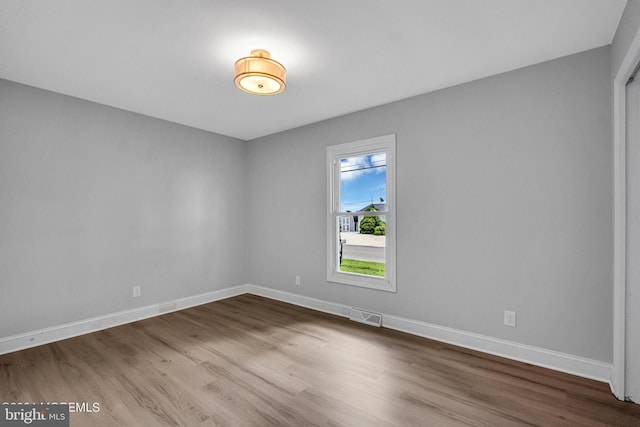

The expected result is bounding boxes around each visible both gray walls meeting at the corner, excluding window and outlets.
[0,44,622,361]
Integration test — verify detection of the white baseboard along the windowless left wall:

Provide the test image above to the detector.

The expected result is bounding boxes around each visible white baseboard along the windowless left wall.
[0,285,247,355]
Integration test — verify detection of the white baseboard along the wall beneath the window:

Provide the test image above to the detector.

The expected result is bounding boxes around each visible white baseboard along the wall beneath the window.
[247,285,613,383]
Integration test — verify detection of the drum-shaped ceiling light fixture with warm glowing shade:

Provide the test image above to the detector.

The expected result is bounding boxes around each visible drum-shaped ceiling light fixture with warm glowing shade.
[234,49,287,95]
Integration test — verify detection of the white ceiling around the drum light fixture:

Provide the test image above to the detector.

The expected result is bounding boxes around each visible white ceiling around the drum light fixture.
[0,0,626,140]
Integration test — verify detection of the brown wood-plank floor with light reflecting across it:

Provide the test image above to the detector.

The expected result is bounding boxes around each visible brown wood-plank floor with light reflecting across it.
[0,295,640,426]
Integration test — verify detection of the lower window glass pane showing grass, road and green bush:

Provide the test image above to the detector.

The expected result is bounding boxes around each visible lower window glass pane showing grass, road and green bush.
[336,213,387,277]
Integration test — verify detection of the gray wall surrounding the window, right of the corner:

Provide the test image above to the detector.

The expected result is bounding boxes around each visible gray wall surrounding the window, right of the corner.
[247,47,612,362]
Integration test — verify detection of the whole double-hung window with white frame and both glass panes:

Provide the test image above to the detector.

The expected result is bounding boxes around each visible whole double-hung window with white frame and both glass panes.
[327,135,396,292]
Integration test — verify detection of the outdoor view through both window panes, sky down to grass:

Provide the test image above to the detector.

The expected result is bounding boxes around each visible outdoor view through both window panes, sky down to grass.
[338,153,387,277]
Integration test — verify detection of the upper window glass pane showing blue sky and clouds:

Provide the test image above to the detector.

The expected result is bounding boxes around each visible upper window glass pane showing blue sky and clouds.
[340,152,387,212]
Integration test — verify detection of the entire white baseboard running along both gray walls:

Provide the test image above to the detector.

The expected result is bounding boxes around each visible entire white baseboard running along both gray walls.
[0,284,613,383]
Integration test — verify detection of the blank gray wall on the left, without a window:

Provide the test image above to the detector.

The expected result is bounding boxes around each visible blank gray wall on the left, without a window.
[0,80,247,337]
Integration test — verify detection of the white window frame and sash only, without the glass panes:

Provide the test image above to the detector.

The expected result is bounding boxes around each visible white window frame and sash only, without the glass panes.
[327,134,396,292]
